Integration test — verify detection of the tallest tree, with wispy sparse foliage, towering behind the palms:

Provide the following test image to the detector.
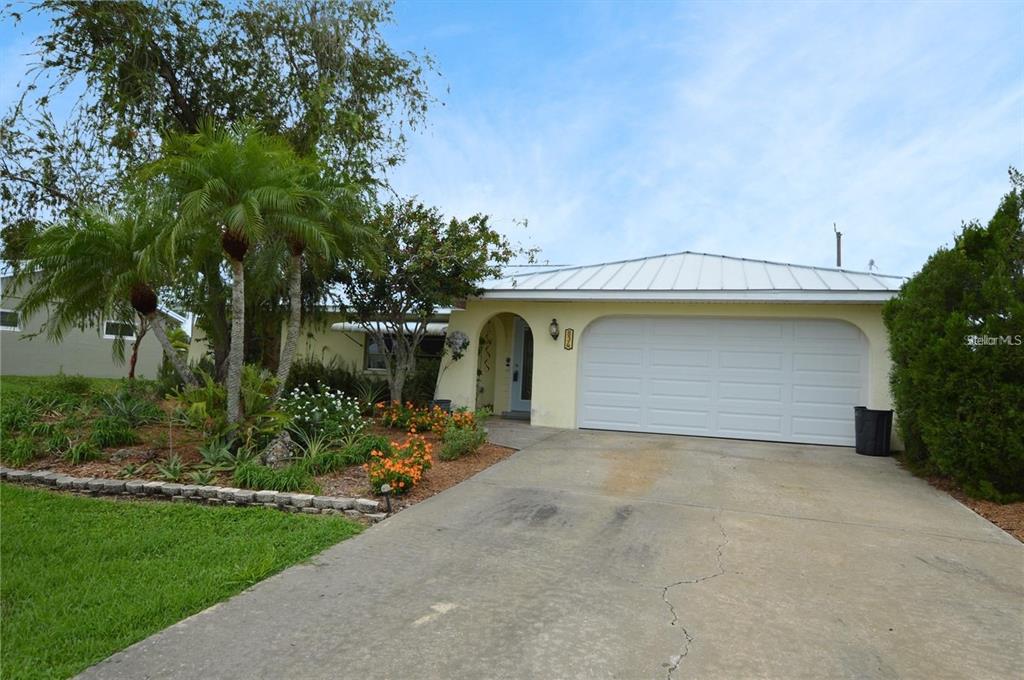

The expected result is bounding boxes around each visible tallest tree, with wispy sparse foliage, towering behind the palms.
[0,0,430,368]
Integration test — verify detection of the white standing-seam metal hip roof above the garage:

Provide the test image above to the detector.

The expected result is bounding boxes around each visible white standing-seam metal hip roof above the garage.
[480,251,904,302]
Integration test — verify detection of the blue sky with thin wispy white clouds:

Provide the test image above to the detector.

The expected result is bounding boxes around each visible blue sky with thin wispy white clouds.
[0,0,1024,274]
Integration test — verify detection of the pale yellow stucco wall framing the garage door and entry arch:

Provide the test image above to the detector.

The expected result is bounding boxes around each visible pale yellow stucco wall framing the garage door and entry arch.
[437,300,892,428]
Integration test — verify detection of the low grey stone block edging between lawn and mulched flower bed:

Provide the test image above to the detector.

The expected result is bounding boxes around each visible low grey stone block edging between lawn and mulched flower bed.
[0,467,388,523]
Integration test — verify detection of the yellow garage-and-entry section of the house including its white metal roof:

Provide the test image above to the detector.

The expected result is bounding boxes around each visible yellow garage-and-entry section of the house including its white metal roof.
[436,252,903,445]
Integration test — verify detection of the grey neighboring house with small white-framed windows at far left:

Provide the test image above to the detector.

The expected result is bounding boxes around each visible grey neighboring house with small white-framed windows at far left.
[0,274,185,378]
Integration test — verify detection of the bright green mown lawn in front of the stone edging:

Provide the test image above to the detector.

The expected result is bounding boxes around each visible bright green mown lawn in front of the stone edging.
[0,484,359,679]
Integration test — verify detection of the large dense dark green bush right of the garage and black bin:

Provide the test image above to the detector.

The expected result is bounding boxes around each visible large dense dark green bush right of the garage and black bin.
[884,176,1024,502]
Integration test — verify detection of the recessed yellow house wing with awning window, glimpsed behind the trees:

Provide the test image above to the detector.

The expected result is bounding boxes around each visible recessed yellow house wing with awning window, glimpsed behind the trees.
[188,307,449,375]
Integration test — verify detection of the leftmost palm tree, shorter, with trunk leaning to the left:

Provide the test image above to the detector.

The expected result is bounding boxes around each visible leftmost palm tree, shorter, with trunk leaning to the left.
[14,205,198,384]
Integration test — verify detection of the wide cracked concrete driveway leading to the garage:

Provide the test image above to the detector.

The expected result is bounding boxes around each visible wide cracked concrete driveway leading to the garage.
[83,428,1024,680]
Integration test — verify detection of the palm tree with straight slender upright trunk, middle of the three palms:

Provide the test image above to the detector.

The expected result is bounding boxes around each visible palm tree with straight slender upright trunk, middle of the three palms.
[146,123,332,423]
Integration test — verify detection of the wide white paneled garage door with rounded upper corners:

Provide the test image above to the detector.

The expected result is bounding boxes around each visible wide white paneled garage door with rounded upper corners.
[579,316,867,445]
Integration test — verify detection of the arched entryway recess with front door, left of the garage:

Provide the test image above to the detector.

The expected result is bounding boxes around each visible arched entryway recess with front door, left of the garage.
[476,312,534,419]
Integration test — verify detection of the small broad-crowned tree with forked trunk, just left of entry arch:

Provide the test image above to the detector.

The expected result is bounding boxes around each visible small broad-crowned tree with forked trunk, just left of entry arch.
[338,200,521,401]
